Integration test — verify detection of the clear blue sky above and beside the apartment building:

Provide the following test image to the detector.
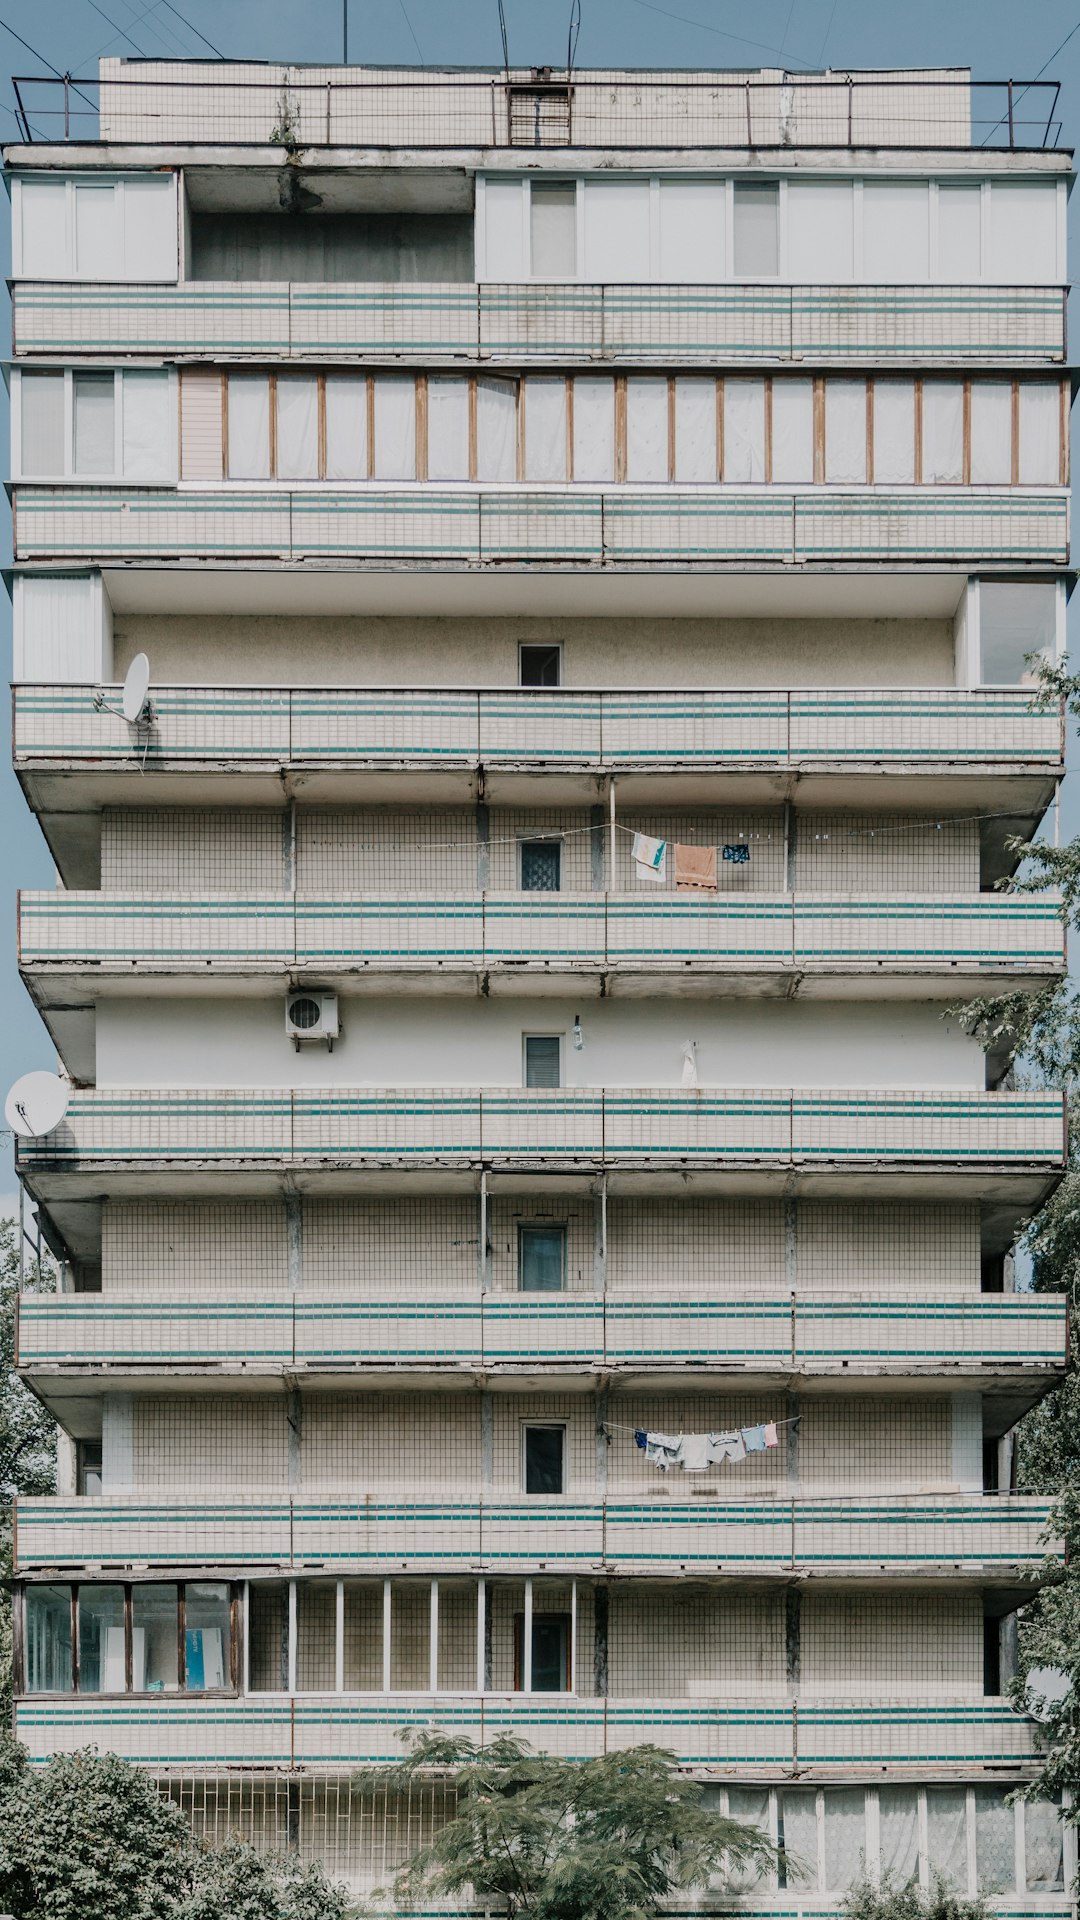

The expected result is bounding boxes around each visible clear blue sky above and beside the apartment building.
[0,0,1080,1212]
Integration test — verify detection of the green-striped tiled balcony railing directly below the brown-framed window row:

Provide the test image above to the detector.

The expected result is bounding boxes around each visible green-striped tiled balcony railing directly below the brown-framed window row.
[15,482,1068,570]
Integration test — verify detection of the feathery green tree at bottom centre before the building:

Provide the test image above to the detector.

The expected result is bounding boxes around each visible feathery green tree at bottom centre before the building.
[356,1730,774,1920]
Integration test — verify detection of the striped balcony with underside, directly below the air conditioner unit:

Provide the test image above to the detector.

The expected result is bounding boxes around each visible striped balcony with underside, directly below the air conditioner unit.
[17,1087,1065,1208]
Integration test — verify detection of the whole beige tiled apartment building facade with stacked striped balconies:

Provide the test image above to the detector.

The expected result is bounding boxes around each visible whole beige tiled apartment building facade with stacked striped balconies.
[6,61,1076,1916]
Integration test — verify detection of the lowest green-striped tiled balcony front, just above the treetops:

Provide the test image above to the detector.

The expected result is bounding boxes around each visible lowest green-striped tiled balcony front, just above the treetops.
[6,1693,1037,1774]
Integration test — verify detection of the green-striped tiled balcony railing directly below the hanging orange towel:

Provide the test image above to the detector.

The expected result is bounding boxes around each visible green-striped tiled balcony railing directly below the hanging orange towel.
[19,891,1065,991]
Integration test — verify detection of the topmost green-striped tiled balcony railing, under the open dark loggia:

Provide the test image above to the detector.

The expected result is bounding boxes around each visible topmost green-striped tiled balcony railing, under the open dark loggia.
[12,280,1067,371]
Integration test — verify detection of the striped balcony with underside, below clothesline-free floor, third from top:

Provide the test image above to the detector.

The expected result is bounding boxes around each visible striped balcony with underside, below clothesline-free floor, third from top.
[13,685,1065,833]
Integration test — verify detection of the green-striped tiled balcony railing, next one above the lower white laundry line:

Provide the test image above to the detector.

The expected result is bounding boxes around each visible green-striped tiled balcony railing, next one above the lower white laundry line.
[17,1281,1067,1380]
